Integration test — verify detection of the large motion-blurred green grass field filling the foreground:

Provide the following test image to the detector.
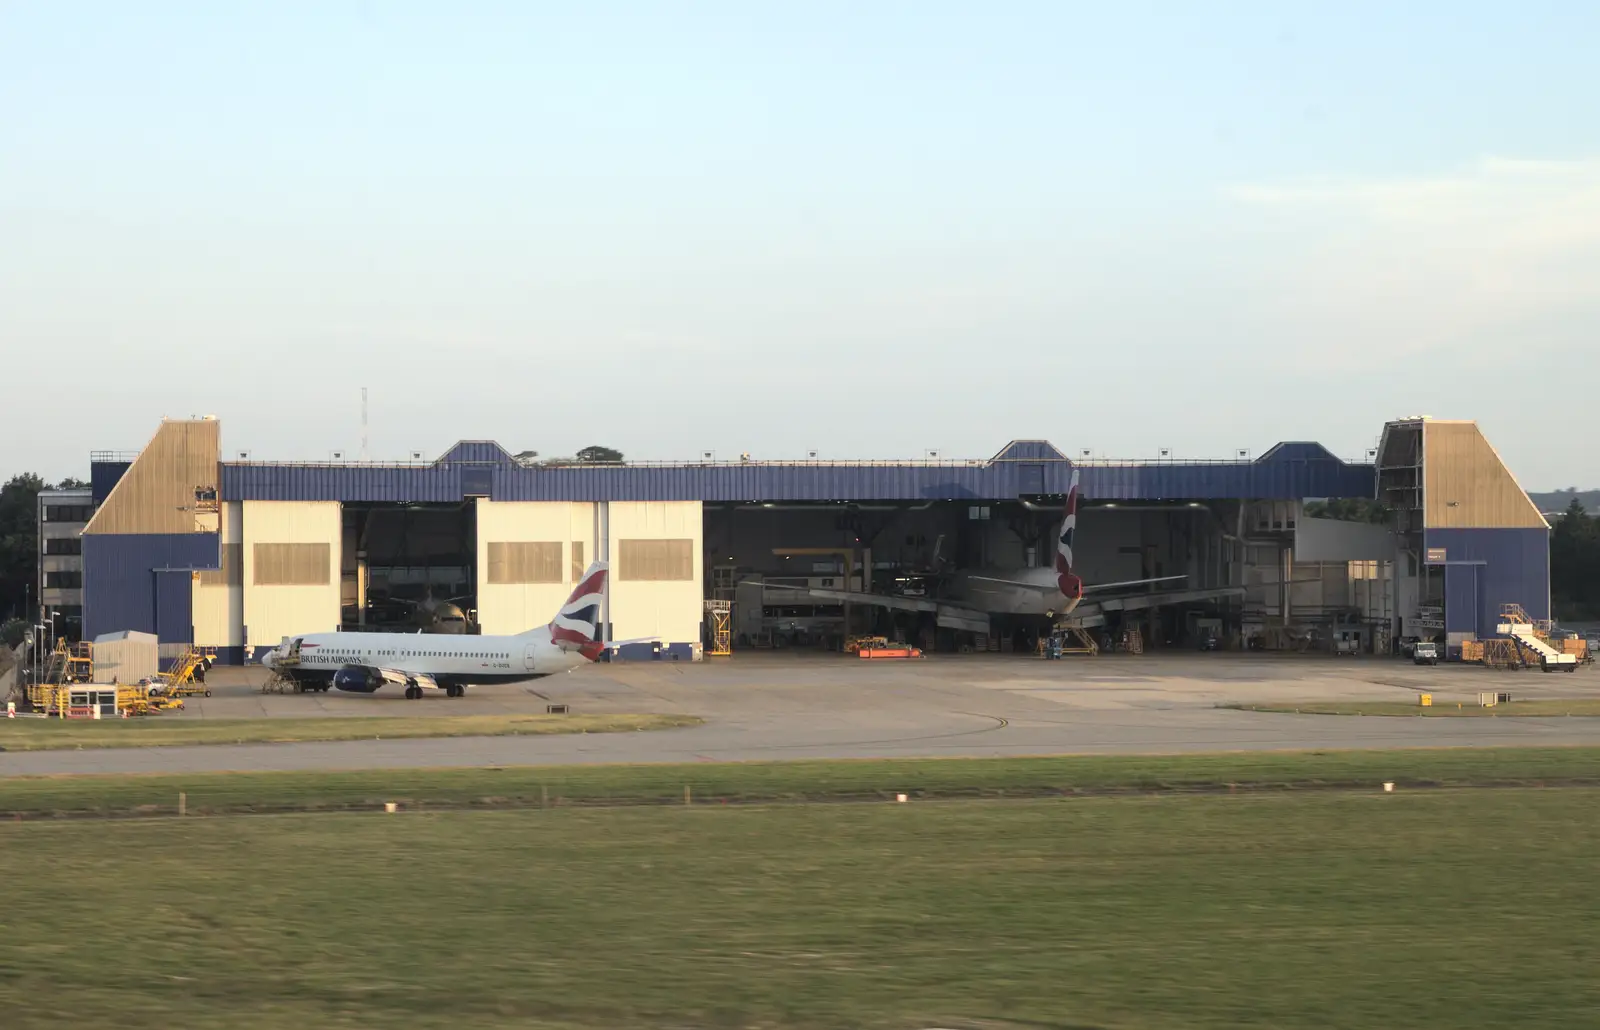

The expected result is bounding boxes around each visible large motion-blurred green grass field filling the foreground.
[0,788,1600,1030]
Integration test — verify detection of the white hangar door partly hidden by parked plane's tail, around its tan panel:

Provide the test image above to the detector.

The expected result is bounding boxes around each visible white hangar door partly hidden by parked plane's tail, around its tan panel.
[477,501,595,633]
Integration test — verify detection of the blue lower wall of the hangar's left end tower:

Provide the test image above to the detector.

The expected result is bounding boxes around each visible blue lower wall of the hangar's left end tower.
[83,533,221,643]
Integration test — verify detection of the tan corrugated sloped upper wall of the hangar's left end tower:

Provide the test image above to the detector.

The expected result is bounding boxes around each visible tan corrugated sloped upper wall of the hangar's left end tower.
[83,419,221,534]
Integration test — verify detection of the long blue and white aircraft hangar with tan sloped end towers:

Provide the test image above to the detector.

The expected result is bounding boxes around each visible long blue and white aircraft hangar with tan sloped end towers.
[82,417,1549,662]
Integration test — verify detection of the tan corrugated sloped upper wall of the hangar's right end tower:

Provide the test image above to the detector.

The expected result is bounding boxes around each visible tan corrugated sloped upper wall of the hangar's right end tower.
[1422,421,1547,529]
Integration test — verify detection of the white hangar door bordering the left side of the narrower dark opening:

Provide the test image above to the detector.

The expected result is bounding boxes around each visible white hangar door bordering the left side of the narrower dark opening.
[240,501,341,648]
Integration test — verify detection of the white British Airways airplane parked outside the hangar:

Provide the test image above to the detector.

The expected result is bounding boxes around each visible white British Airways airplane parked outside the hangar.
[261,561,614,701]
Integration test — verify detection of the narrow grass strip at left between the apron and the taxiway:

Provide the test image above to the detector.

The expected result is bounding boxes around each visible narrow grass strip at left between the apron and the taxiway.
[0,715,701,752]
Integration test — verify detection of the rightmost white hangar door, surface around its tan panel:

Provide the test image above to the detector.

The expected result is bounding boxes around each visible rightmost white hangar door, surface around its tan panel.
[608,501,706,645]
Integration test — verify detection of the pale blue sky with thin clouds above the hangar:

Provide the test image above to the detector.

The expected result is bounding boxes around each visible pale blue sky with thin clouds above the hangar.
[0,0,1600,489]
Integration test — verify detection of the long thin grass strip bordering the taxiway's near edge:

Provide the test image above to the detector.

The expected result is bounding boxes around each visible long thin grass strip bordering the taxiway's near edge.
[0,747,1600,817]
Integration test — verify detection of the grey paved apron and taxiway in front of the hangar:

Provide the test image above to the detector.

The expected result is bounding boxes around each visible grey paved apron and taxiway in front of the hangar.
[0,656,1600,776]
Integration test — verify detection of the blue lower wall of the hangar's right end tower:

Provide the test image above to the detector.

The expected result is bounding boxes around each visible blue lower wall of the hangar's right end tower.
[1424,529,1550,637]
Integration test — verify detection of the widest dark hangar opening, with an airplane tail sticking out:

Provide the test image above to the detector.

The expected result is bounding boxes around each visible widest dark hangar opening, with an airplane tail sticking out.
[706,494,1243,651]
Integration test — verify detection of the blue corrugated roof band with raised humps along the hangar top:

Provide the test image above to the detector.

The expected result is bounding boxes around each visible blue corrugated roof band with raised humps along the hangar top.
[221,440,1374,504]
